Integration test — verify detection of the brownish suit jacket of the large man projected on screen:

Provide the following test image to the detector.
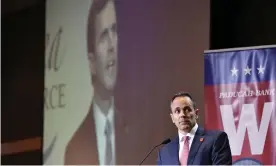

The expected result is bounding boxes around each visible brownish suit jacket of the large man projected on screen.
[64,104,129,165]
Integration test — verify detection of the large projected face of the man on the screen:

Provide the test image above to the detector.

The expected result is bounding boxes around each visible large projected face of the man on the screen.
[93,1,118,90]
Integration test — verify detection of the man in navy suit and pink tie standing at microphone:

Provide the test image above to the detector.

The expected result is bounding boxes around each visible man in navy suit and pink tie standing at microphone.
[157,92,232,165]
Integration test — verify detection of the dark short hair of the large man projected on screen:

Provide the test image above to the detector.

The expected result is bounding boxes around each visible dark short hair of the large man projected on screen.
[86,0,111,53]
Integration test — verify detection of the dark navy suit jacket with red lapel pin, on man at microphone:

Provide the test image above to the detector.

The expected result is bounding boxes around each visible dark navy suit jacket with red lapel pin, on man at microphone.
[157,127,232,165]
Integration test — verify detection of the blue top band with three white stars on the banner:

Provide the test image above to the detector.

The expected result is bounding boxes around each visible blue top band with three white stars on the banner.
[204,48,276,85]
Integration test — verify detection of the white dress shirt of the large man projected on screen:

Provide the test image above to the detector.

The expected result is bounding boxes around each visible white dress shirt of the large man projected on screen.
[93,100,116,165]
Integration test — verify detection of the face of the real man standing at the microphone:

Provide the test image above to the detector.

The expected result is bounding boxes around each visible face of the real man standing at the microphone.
[171,97,198,133]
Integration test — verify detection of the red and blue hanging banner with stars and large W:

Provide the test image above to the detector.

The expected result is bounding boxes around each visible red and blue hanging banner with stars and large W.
[204,46,276,165]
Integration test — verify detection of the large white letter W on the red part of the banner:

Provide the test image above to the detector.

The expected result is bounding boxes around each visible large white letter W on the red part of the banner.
[220,102,273,156]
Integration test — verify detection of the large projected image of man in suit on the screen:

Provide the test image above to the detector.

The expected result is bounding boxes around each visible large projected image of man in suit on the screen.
[65,0,131,165]
